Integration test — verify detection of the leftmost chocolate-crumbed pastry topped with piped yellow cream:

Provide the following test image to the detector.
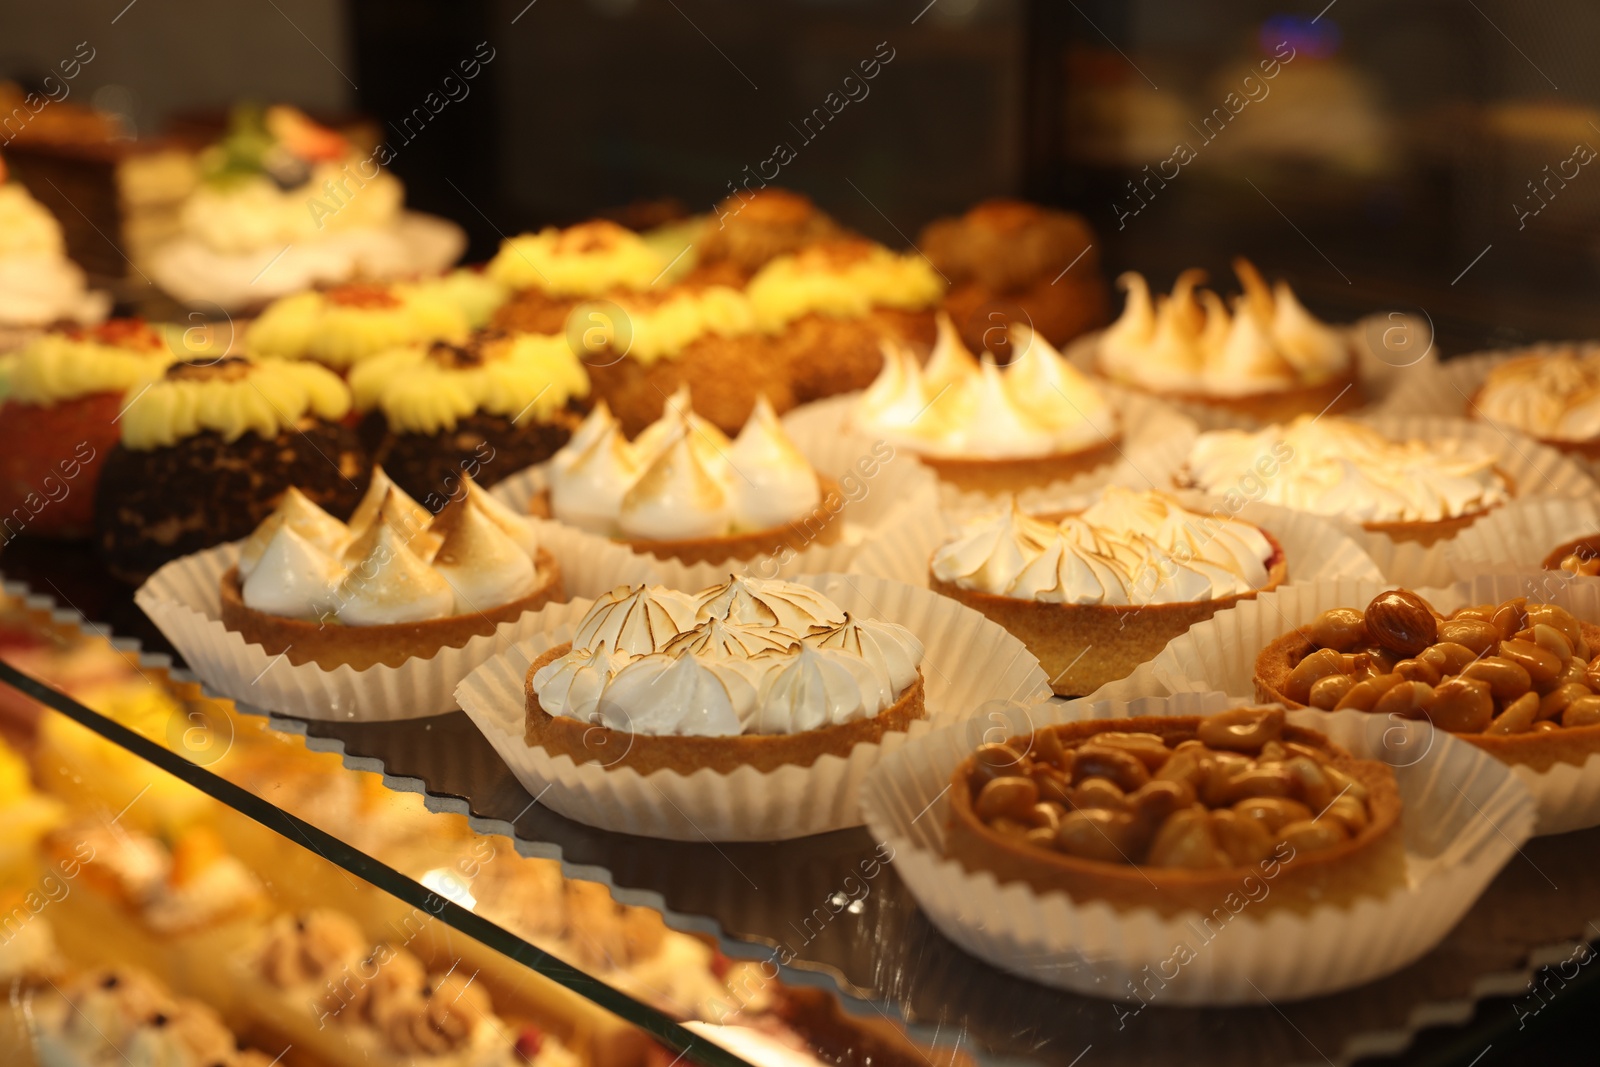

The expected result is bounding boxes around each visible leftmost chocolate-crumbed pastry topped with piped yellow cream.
[94,355,370,581]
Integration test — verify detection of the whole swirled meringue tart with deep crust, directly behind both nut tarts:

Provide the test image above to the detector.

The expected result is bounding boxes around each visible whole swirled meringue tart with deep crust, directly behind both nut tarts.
[930,486,1288,696]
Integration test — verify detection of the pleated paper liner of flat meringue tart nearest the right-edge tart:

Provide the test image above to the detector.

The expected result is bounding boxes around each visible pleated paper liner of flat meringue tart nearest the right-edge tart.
[1290,414,1600,589]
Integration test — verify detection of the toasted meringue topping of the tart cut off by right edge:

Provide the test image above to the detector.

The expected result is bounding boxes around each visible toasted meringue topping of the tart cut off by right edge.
[1474,346,1600,442]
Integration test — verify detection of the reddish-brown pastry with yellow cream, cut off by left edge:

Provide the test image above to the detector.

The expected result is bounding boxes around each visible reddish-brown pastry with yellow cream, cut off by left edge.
[0,316,174,542]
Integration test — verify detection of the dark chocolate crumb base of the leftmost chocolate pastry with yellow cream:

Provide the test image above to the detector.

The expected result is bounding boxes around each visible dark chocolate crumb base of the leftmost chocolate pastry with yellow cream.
[94,419,371,582]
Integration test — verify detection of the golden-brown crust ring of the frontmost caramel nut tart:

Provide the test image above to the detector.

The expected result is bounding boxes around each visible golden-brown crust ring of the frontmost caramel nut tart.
[944,715,1405,917]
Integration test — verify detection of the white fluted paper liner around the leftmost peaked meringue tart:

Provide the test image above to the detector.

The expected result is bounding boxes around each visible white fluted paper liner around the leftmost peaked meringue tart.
[133,526,659,721]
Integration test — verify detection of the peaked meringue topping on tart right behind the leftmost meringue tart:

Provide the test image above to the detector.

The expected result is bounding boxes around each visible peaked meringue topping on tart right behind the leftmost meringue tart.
[547,386,822,541]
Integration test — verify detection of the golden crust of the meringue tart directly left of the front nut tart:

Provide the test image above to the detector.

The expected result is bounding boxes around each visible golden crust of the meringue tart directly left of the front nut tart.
[523,641,926,776]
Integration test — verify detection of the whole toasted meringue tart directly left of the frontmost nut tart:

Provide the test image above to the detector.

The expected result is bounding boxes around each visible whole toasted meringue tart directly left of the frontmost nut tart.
[525,577,925,776]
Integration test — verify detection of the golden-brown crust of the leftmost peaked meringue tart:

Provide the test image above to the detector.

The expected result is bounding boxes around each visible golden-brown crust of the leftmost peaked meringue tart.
[222,549,566,670]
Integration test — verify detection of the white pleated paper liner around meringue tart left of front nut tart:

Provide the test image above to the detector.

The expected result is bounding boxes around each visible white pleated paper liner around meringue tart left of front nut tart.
[456,574,1050,841]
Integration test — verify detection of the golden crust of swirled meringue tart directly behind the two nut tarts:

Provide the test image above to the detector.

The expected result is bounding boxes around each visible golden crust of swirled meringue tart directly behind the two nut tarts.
[928,526,1290,696]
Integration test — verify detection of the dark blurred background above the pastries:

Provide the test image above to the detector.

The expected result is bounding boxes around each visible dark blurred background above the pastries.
[0,0,1600,352]
